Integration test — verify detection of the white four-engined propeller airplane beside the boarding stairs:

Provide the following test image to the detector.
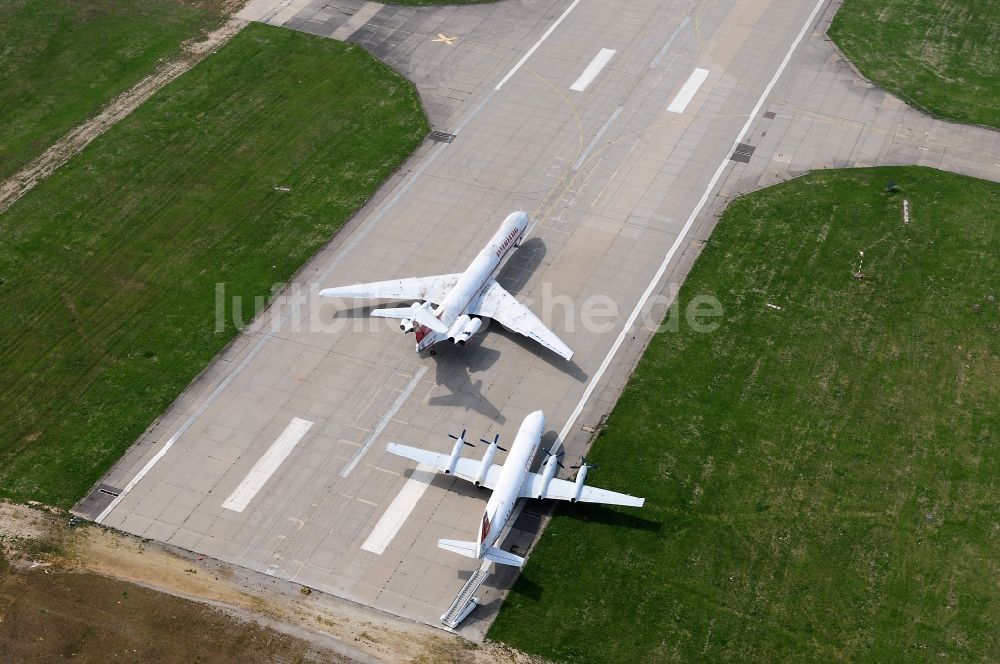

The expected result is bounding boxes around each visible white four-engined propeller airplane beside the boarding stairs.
[386,410,646,567]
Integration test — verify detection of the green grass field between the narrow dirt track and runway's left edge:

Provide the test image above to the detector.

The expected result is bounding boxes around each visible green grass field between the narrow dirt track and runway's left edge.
[0,24,427,506]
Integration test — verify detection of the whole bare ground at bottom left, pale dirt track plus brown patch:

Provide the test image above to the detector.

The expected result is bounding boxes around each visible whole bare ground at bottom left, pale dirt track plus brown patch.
[0,503,538,664]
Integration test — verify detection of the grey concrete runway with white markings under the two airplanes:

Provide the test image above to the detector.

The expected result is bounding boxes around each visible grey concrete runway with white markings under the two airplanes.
[76,0,1000,638]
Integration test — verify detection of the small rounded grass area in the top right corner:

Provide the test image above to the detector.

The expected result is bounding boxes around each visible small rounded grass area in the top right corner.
[829,0,1000,127]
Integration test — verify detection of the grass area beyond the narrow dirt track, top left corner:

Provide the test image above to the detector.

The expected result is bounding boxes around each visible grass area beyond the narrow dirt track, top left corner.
[0,0,229,179]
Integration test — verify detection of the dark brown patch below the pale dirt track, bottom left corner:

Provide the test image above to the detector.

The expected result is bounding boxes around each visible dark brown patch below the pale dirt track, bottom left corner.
[0,569,350,663]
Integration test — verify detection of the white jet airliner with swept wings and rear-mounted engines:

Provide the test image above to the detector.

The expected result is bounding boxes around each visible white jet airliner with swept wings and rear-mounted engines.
[319,212,573,360]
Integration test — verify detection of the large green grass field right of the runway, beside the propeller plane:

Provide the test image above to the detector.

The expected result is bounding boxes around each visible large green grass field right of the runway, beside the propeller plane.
[489,167,1000,662]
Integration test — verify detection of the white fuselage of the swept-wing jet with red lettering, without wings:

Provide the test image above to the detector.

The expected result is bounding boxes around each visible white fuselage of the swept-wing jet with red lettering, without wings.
[415,212,528,352]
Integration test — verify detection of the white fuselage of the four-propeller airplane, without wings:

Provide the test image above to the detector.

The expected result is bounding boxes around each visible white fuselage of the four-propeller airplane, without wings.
[477,410,545,557]
